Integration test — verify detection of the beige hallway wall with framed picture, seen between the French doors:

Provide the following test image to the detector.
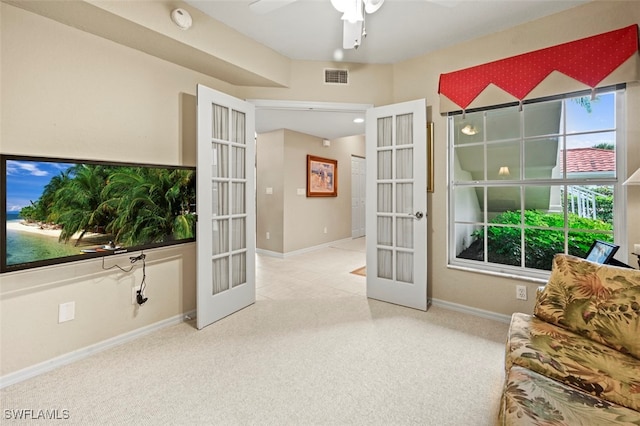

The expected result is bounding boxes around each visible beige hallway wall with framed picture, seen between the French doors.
[257,130,365,254]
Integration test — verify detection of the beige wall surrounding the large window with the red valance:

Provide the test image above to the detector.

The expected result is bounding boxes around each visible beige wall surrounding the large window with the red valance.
[393,1,640,315]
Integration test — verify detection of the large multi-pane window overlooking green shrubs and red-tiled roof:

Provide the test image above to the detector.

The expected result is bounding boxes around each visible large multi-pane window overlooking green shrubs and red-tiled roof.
[449,89,624,278]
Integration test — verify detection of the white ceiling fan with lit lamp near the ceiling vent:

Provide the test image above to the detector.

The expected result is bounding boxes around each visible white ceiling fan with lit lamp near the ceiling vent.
[249,0,384,49]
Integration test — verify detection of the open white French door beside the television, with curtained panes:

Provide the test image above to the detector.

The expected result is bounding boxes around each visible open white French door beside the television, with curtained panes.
[196,85,256,329]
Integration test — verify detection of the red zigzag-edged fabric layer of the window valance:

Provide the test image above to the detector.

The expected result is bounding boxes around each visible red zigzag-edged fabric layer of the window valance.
[438,25,638,110]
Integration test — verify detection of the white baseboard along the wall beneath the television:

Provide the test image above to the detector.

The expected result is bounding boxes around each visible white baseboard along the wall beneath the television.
[0,310,196,389]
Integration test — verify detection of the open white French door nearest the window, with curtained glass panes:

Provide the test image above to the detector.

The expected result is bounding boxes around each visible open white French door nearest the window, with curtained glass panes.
[366,99,427,310]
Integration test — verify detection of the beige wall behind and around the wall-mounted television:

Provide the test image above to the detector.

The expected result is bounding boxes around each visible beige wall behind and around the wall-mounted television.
[0,3,230,375]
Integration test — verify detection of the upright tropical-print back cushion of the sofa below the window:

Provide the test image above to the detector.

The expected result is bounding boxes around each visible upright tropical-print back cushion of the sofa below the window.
[534,254,640,359]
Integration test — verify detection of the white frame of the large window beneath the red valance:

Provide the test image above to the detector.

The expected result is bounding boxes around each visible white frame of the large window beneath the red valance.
[447,84,628,282]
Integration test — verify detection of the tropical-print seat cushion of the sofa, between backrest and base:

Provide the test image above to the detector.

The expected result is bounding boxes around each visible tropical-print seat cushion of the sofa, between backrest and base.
[506,313,640,411]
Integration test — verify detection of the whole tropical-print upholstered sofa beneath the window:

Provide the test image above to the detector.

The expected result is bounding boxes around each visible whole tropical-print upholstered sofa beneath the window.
[499,254,640,425]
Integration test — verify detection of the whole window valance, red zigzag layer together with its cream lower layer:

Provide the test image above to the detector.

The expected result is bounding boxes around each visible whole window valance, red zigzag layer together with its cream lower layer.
[438,25,640,113]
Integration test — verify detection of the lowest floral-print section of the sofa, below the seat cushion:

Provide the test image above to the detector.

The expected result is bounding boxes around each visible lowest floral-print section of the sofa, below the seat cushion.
[499,366,640,426]
